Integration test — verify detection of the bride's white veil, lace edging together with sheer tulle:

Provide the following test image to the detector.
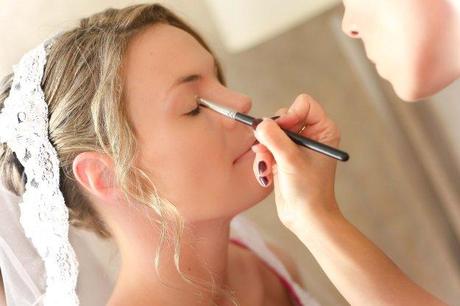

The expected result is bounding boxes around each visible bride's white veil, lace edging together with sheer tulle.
[0,33,120,306]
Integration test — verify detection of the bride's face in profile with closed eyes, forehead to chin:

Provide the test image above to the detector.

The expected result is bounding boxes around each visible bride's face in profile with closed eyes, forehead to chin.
[124,24,272,222]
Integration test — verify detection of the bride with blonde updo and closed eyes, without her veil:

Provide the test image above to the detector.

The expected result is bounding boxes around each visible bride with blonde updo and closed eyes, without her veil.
[0,4,316,306]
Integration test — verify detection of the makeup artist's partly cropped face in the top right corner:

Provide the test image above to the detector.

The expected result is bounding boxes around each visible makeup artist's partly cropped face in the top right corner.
[343,0,460,101]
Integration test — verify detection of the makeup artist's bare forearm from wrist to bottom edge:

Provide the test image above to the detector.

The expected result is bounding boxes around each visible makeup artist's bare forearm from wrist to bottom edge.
[296,209,446,306]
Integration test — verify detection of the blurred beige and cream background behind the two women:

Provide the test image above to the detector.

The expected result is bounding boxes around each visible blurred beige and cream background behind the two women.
[0,0,460,305]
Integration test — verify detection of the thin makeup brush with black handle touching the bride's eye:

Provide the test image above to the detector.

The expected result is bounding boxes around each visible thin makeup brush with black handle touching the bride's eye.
[196,97,349,161]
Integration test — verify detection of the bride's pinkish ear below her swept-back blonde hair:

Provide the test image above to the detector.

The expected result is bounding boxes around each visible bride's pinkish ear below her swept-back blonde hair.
[72,151,118,201]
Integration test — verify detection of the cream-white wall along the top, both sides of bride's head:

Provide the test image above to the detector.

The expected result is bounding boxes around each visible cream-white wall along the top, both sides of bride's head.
[0,0,340,76]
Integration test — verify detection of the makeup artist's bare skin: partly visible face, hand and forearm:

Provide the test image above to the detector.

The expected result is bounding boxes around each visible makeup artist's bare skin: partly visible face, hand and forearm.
[253,0,460,305]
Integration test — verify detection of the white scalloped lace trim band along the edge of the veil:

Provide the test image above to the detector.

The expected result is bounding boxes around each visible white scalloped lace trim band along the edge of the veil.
[0,39,79,306]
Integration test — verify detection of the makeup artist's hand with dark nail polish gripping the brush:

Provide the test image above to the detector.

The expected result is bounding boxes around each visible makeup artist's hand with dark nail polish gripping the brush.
[252,94,340,232]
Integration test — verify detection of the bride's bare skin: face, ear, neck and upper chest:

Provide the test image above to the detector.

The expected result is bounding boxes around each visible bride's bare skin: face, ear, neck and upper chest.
[73,24,298,306]
